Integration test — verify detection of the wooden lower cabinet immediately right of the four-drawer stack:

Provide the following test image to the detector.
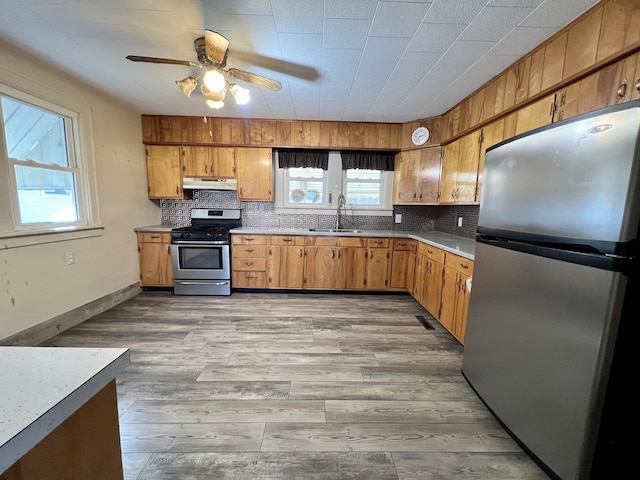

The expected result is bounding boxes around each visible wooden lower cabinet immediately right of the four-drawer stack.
[267,235,304,288]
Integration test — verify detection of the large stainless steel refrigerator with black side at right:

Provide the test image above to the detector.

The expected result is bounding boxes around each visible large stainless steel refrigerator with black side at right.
[462,102,640,480]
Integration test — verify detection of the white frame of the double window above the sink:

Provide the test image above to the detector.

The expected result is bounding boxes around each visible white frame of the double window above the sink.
[275,151,393,217]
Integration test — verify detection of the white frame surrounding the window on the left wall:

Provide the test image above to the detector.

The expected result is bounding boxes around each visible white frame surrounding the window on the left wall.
[0,83,101,240]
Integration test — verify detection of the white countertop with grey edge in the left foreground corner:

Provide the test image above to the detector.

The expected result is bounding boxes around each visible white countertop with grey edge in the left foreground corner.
[0,347,129,474]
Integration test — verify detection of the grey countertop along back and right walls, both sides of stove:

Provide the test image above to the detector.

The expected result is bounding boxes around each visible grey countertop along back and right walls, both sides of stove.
[134,225,476,260]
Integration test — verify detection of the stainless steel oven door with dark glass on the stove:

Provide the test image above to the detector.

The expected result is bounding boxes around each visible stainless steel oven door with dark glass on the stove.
[171,241,231,280]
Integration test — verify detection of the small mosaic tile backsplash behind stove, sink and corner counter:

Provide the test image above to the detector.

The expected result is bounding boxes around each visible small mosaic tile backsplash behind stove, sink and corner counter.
[160,190,478,238]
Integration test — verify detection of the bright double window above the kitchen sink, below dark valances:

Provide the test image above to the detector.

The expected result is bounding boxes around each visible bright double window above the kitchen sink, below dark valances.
[276,152,393,215]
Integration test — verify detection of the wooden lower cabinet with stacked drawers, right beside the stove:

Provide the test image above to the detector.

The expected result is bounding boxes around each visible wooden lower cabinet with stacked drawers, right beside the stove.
[231,235,267,288]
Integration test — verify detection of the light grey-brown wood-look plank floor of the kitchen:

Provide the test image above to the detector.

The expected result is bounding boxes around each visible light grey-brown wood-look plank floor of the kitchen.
[43,292,548,480]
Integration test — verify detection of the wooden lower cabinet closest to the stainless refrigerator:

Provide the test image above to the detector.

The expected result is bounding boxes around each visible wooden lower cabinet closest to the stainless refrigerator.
[439,254,473,344]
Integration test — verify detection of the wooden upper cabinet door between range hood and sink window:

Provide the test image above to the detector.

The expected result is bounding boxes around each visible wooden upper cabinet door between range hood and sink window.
[236,148,273,202]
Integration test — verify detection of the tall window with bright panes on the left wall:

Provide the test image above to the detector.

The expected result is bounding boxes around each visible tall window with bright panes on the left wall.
[0,87,89,230]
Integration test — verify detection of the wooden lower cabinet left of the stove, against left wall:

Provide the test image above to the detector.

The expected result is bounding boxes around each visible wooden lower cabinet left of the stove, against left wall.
[137,232,173,287]
